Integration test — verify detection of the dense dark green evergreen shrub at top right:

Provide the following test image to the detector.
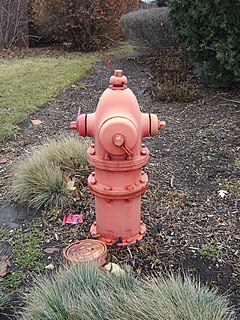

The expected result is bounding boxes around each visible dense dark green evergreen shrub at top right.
[169,0,240,85]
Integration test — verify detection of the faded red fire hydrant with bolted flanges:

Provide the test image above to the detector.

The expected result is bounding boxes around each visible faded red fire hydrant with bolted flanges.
[70,70,165,245]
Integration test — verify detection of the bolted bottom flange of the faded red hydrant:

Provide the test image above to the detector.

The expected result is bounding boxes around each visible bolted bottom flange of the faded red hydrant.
[90,221,146,246]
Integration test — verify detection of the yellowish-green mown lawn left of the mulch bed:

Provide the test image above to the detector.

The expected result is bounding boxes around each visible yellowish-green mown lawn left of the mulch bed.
[0,45,132,141]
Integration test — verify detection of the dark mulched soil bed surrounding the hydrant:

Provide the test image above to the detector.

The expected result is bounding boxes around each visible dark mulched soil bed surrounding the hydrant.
[0,48,240,318]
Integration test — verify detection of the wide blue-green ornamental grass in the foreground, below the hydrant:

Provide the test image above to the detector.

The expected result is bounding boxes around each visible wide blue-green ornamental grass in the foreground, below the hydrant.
[21,264,234,320]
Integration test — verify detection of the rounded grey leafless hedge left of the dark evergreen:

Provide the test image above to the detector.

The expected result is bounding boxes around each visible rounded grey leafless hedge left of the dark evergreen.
[120,8,176,51]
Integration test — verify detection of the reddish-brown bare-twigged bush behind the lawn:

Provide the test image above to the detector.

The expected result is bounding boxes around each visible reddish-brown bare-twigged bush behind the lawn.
[31,0,138,51]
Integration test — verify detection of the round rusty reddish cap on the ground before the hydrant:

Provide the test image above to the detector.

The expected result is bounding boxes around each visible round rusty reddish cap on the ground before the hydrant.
[63,239,107,267]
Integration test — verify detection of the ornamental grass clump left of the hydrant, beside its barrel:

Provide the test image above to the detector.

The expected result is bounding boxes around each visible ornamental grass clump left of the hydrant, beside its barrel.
[13,137,89,209]
